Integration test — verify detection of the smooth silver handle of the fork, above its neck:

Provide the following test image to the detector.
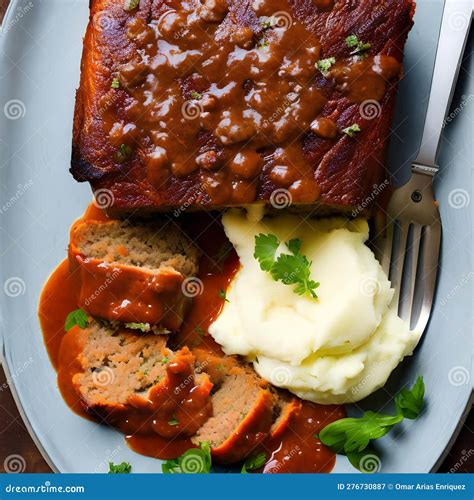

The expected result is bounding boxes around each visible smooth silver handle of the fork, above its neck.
[415,0,472,169]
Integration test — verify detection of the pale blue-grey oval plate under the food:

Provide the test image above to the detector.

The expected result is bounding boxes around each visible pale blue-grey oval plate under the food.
[0,0,474,472]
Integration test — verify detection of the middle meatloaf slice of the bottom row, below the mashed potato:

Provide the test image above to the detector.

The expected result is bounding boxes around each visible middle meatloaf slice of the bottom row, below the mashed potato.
[192,365,275,464]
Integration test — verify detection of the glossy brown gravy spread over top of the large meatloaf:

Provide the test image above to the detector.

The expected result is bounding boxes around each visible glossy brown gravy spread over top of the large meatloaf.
[101,0,401,205]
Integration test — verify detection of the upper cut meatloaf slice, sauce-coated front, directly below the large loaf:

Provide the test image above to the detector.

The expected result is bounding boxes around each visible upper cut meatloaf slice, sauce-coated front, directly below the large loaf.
[69,220,199,331]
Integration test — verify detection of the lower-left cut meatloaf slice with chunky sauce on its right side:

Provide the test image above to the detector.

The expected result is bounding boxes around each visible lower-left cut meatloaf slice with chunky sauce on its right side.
[72,322,213,438]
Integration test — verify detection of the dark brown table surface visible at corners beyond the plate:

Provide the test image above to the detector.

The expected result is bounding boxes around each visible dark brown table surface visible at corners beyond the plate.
[0,0,474,473]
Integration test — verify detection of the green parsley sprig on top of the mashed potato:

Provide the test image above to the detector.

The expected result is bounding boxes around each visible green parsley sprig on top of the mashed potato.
[253,234,319,299]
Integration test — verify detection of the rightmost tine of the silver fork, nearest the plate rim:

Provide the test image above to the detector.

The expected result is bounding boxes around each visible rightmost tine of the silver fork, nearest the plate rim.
[413,219,441,332]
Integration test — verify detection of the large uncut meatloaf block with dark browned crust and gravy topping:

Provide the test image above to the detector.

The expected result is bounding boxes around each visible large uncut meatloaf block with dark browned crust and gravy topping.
[71,0,414,213]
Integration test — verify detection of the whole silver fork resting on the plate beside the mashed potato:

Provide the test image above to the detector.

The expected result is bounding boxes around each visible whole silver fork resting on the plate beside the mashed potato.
[374,0,472,334]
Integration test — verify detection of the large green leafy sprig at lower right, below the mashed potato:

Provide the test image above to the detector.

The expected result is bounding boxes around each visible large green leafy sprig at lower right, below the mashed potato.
[315,376,425,467]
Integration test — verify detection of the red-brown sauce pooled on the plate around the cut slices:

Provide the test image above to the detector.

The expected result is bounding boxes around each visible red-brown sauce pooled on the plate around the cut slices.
[39,207,344,473]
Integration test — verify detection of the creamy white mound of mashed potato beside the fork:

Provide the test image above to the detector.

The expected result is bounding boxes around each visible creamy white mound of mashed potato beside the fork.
[209,211,419,404]
